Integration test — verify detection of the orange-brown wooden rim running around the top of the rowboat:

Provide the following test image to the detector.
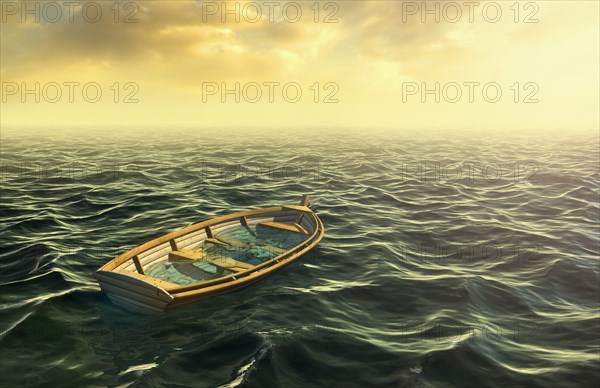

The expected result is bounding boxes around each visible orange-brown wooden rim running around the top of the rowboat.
[97,206,324,296]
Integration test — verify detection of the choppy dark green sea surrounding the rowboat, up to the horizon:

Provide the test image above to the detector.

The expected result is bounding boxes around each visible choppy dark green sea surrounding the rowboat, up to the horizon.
[0,129,600,387]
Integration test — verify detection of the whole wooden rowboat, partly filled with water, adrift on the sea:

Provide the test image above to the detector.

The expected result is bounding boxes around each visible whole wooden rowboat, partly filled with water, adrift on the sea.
[94,195,324,313]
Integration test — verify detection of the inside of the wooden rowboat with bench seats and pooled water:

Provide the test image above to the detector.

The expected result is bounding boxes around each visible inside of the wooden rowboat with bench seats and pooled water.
[108,200,320,288]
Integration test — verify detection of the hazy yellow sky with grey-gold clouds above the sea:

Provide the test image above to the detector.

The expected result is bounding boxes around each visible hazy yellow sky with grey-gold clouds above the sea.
[0,0,600,131]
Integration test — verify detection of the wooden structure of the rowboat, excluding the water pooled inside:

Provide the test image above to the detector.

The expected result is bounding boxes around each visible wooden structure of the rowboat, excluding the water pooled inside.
[95,196,324,313]
